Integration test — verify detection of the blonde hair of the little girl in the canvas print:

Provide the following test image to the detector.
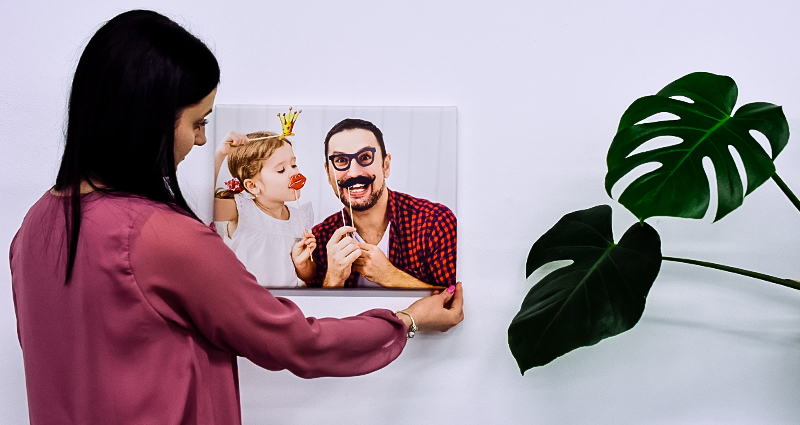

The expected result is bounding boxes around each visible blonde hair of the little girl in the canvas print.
[215,131,292,199]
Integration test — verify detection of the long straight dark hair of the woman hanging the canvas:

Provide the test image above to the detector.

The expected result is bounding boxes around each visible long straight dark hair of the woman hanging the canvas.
[55,10,219,283]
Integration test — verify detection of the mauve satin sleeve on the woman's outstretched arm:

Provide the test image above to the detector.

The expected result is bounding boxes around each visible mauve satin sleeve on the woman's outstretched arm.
[130,210,406,378]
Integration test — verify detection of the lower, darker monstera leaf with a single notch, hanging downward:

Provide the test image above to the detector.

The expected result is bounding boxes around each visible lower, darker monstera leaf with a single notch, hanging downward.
[508,205,661,373]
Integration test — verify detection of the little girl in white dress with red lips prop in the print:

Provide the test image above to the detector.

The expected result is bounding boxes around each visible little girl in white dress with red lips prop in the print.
[214,131,316,288]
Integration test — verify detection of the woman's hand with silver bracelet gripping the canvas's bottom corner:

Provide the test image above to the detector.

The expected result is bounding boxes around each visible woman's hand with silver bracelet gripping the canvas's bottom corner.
[397,282,464,332]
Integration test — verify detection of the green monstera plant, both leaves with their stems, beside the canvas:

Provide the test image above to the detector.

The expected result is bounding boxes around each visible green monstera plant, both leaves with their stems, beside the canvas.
[508,72,800,373]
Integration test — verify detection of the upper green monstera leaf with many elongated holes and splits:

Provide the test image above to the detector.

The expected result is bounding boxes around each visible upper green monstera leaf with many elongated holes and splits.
[605,72,789,221]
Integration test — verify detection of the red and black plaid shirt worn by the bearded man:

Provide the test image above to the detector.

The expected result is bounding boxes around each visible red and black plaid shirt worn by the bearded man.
[308,189,456,288]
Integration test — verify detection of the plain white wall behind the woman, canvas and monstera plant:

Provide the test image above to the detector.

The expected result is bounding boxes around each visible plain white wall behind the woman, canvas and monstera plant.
[0,0,800,424]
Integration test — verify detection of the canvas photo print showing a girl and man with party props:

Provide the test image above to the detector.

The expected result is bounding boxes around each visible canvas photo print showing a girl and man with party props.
[210,105,458,292]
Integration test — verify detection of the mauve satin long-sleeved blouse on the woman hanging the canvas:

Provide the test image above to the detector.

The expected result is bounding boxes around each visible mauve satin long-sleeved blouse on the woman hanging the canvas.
[11,193,406,424]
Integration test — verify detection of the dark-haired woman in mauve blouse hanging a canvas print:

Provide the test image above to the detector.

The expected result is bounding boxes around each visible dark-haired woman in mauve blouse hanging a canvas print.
[11,11,463,424]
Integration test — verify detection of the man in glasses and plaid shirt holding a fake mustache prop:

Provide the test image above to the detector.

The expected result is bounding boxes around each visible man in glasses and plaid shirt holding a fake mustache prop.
[309,118,456,288]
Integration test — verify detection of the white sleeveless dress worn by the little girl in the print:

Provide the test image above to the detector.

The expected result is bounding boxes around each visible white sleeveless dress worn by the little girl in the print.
[223,193,314,288]
